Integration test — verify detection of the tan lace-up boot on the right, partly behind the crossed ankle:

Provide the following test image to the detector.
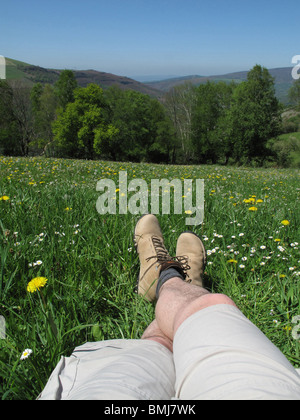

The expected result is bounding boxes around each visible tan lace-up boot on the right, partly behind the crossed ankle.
[176,232,206,287]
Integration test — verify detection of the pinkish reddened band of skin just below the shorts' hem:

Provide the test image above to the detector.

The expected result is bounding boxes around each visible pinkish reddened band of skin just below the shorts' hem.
[174,293,237,334]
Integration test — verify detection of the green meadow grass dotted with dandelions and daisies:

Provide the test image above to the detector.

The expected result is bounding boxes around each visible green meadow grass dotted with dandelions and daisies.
[0,157,300,400]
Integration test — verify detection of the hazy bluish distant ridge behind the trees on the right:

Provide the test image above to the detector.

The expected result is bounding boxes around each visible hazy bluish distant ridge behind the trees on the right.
[145,67,294,103]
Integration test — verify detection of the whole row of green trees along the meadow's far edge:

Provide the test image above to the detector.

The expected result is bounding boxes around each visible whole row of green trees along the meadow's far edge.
[0,65,300,165]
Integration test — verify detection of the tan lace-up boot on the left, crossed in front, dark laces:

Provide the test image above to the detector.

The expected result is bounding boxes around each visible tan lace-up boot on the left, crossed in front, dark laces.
[134,214,184,302]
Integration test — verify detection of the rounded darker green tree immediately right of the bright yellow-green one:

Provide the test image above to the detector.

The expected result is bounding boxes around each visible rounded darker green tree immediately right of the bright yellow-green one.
[102,87,172,162]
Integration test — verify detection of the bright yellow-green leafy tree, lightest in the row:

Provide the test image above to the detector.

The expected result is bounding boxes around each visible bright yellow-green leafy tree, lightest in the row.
[53,84,116,159]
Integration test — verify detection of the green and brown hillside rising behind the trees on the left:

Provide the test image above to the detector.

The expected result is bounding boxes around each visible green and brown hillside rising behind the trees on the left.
[6,58,163,98]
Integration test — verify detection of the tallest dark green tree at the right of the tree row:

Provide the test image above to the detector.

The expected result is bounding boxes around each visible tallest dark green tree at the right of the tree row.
[227,65,281,163]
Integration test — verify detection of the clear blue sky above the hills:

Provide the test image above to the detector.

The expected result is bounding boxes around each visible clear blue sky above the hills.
[0,0,300,77]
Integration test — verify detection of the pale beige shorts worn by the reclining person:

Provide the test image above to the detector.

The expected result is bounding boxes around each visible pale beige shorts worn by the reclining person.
[38,305,300,400]
